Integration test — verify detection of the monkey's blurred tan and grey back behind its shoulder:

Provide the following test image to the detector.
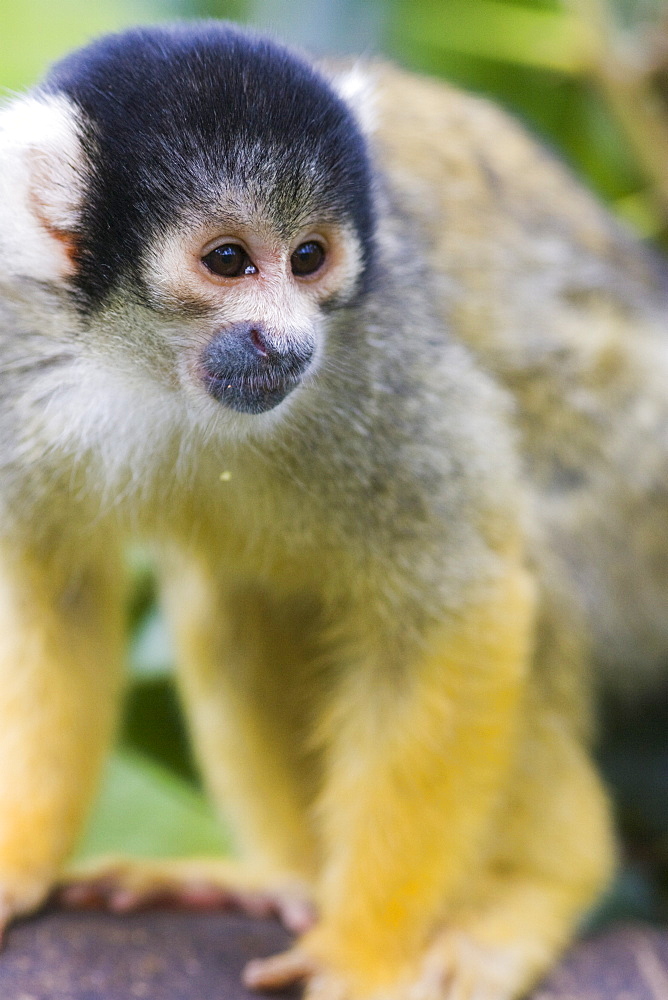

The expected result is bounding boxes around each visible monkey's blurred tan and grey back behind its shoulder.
[374,67,668,677]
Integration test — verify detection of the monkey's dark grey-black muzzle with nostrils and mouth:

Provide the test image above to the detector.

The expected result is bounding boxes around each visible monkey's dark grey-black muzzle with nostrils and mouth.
[200,323,314,413]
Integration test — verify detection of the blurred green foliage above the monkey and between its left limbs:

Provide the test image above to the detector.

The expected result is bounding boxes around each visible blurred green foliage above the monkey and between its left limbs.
[0,0,663,911]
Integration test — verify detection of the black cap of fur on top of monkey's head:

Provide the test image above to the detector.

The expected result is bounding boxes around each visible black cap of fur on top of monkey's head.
[43,21,373,309]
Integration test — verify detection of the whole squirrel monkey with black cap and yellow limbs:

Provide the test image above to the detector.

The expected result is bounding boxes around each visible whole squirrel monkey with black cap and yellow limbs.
[0,22,668,1000]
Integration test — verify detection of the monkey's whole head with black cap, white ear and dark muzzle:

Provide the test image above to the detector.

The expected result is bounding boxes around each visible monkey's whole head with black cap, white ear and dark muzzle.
[0,22,374,422]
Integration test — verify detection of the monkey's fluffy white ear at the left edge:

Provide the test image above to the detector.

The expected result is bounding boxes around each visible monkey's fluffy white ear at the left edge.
[0,95,85,280]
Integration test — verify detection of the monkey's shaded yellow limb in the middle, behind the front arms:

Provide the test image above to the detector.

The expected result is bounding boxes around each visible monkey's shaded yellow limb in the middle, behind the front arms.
[163,554,317,884]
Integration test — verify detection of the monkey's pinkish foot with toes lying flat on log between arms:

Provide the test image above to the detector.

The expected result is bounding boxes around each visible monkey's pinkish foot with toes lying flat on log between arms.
[56,858,315,934]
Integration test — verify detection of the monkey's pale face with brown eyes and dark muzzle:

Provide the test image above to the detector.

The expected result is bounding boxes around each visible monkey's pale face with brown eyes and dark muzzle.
[144,211,361,414]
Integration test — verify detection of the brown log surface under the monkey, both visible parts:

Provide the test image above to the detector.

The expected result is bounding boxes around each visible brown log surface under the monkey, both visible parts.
[0,910,668,1000]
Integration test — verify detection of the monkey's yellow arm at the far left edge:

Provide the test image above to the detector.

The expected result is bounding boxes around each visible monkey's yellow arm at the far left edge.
[0,539,123,927]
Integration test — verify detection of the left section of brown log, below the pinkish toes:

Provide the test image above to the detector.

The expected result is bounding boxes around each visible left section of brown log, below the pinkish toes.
[0,910,300,1000]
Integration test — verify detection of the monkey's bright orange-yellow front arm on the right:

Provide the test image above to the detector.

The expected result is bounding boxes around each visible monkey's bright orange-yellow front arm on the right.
[249,564,534,995]
